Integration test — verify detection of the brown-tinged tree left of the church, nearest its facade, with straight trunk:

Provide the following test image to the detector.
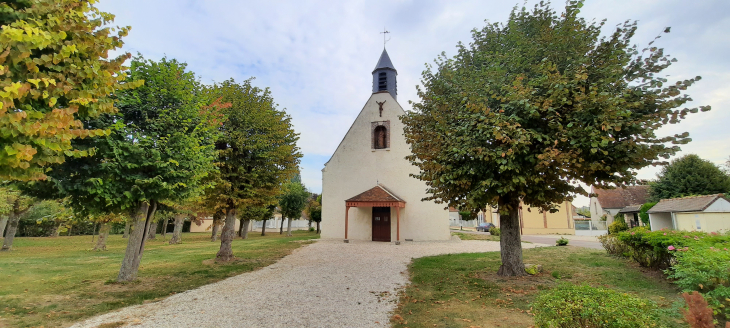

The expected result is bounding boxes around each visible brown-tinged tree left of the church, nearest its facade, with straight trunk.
[206,79,301,262]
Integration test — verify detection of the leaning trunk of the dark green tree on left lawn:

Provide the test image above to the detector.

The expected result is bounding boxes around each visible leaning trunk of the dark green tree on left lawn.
[117,201,157,282]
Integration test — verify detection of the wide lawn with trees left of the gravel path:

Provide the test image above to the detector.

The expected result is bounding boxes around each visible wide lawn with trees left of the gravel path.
[0,231,319,327]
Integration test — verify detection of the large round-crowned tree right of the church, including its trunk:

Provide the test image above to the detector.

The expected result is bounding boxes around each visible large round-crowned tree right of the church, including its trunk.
[402,0,710,276]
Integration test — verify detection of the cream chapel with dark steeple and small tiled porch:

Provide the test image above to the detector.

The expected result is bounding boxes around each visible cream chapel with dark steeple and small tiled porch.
[321,49,451,244]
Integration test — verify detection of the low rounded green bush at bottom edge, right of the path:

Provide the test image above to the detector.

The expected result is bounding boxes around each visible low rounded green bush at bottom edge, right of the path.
[535,283,658,328]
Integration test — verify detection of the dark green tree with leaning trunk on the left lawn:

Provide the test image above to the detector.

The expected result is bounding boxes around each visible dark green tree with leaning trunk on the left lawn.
[42,56,222,281]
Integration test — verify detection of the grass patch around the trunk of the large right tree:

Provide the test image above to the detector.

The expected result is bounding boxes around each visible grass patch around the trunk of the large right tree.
[391,247,688,328]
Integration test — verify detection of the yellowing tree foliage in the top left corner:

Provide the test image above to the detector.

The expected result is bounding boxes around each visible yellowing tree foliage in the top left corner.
[0,0,141,180]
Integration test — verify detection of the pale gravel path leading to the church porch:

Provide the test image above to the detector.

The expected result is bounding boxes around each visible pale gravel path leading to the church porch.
[73,240,541,327]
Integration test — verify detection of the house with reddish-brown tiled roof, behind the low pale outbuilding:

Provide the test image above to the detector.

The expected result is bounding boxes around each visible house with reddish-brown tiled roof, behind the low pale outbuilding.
[589,186,649,229]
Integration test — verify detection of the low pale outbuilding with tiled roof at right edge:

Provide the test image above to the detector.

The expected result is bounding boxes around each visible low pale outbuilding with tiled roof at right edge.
[647,194,730,232]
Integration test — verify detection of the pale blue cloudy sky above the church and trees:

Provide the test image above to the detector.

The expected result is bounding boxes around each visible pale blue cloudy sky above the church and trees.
[97,0,730,206]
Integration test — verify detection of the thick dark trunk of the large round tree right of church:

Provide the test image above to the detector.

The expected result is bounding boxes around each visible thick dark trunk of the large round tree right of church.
[497,198,526,276]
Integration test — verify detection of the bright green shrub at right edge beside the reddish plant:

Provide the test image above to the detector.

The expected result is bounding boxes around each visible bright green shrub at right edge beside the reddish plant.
[667,246,730,320]
